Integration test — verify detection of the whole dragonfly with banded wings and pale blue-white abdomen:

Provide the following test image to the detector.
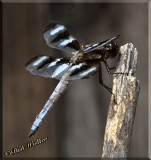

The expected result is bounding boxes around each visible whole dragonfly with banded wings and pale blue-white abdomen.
[26,23,119,137]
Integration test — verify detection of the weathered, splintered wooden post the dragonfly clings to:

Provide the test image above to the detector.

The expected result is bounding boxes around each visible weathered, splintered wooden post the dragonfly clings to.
[102,43,140,158]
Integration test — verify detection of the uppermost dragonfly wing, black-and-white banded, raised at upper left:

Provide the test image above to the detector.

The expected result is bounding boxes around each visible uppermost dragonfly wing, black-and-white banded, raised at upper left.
[44,23,82,54]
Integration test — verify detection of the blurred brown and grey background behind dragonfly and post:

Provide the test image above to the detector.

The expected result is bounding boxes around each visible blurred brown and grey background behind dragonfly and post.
[3,3,148,157]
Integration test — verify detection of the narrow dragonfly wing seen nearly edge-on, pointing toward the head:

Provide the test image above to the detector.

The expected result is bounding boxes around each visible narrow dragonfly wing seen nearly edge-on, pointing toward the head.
[80,35,119,54]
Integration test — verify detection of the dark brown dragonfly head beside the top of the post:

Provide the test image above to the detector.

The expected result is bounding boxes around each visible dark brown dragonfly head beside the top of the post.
[106,42,119,58]
